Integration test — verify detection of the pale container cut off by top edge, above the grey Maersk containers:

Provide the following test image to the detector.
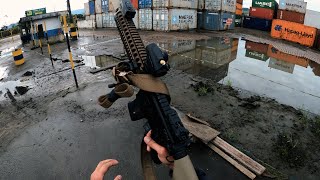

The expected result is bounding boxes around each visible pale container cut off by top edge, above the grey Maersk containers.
[152,0,198,9]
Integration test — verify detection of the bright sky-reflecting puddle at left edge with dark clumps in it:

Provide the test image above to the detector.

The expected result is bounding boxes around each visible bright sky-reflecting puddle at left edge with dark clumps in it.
[0,79,32,100]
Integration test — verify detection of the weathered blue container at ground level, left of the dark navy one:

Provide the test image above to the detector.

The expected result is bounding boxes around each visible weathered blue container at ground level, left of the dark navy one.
[203,11,235,31]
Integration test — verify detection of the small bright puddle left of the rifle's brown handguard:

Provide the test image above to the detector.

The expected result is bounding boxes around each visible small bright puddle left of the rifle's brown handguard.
[81,55,119,68]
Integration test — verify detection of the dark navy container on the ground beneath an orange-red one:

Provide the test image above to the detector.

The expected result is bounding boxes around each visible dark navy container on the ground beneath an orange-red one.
[242,16,272,31]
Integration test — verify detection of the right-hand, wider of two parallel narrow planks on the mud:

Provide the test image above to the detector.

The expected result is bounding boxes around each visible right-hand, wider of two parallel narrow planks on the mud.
[212,137,266,175]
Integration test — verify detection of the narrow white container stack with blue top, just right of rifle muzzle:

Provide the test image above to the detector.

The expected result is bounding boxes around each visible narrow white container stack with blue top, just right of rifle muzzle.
[138,0,152,30]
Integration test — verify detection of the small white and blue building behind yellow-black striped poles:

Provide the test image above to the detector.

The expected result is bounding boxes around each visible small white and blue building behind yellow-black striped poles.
[19,11,67,45]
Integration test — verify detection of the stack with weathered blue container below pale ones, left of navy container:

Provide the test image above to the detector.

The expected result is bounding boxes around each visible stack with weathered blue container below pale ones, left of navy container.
[200,0,237,31]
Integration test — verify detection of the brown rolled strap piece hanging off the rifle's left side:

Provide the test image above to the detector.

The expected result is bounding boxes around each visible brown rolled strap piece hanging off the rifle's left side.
[98,83,134,108]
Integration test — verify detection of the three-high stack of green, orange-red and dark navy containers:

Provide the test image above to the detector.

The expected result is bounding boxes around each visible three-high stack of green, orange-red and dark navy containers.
[243,0,278,31]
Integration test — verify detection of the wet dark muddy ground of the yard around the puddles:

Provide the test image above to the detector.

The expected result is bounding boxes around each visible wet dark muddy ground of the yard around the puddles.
[0,29,320,179]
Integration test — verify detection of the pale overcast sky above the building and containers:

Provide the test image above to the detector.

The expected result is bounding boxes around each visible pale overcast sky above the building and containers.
[0,0,320,27]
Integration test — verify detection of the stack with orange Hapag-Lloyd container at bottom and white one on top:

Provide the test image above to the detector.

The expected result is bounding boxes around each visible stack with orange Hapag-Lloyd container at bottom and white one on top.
[271,0,317,47]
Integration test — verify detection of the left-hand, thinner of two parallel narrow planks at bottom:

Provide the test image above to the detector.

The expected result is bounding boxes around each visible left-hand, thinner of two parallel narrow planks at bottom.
[208,143,256,179]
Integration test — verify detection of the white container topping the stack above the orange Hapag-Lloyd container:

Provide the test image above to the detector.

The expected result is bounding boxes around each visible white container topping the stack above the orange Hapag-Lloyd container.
[279,0,307,14]
